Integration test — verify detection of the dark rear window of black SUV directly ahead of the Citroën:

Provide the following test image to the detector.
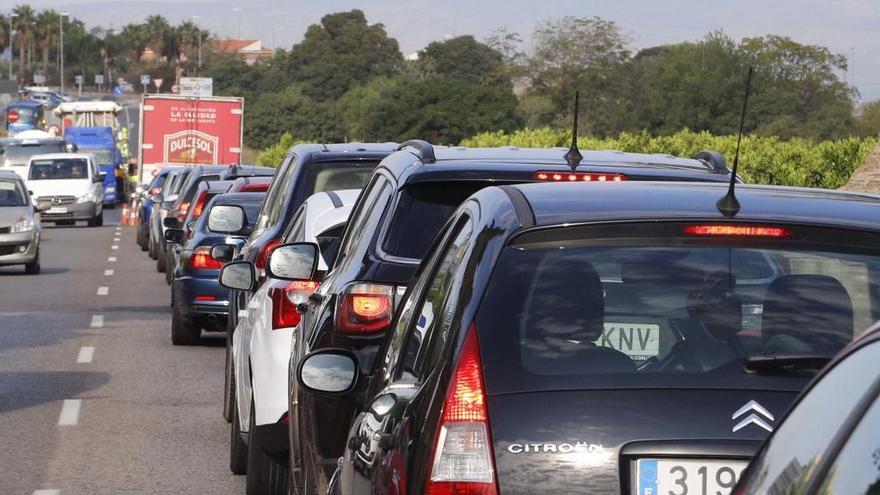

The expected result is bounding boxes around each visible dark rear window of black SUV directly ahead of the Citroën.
[383,182,489,259]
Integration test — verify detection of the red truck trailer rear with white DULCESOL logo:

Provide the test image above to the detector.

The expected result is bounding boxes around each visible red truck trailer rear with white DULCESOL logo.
[138,94,244,184]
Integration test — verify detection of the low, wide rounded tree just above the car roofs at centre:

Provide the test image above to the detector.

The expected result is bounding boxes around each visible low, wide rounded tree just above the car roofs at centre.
[363,78,521,144]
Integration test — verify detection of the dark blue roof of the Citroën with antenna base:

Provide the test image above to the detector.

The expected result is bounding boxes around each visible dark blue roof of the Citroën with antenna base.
[510,181,880,230]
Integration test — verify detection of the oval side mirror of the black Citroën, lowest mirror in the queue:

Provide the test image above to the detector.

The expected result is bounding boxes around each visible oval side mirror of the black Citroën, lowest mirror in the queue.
[296,348,358,395]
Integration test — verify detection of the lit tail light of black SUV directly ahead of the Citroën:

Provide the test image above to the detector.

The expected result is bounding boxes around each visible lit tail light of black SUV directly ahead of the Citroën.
[336,283,394,334]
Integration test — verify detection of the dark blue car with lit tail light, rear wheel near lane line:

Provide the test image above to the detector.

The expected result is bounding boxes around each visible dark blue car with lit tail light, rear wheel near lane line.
[165,192,266,345]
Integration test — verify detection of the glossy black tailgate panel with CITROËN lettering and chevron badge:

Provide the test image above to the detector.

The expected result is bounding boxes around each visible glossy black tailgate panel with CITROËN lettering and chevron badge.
[488,389,796,494]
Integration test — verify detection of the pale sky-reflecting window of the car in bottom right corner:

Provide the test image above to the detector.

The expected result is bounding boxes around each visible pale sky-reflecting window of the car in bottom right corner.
[743,344,880,495]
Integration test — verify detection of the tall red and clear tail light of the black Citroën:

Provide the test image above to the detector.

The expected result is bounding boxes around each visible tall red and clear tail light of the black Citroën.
[425,325,498,495]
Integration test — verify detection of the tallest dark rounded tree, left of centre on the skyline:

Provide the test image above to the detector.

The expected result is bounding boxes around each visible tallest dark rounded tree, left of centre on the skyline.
[286,10,403,101]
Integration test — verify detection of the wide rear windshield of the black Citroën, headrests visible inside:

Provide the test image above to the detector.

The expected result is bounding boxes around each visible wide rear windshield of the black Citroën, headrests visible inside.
[477,225,880,393]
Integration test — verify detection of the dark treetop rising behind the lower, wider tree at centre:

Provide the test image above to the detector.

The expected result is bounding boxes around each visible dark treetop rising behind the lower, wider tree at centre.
[419,35,511,87]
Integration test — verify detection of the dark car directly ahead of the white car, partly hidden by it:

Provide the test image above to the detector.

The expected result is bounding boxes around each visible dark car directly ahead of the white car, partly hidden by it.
[223,143,397,421]
